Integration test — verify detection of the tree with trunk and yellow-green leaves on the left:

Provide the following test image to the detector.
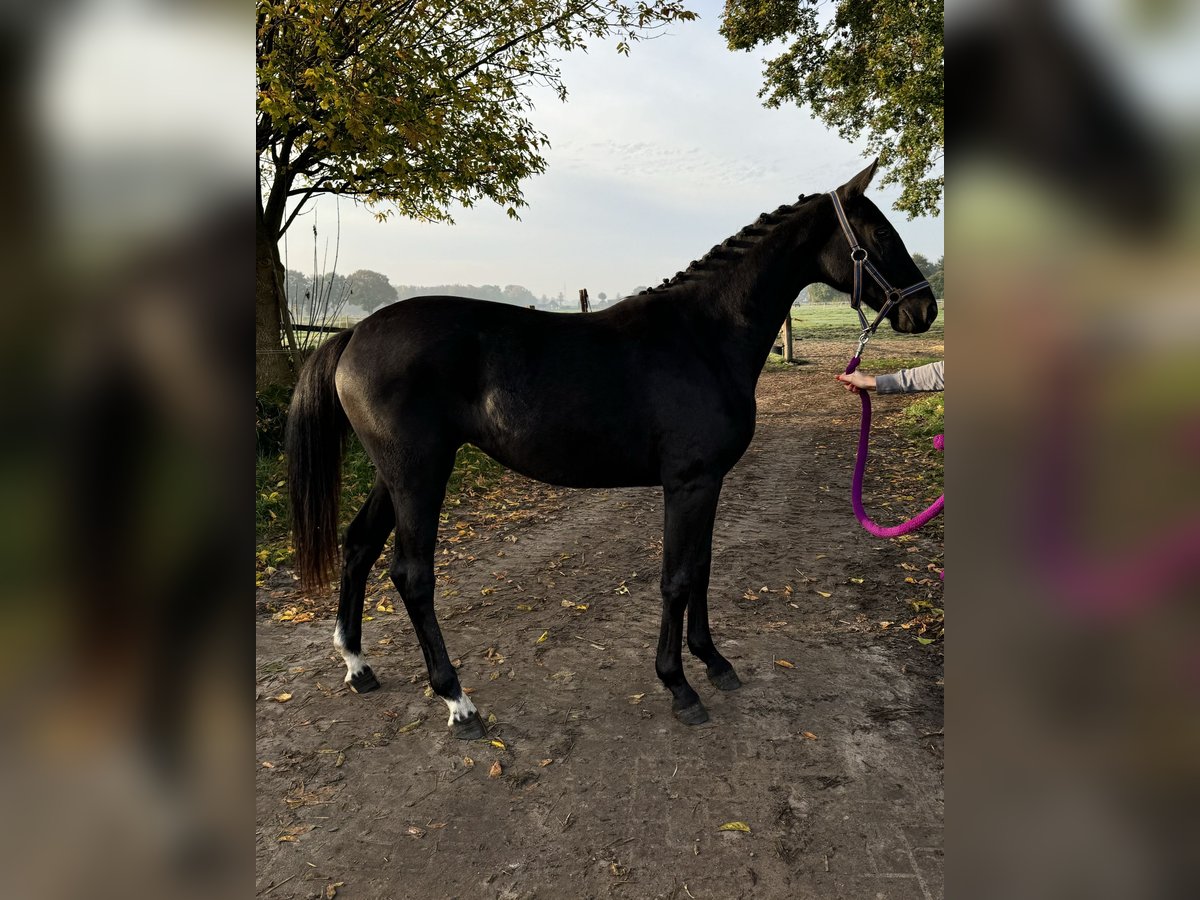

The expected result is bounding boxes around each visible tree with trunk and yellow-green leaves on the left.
[256,0,695,384]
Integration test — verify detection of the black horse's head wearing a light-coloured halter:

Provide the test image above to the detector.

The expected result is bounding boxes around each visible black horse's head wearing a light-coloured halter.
[820,161,937,335]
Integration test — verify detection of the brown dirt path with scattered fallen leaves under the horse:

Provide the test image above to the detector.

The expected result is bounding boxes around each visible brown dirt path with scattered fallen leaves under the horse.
[256,338,942,900]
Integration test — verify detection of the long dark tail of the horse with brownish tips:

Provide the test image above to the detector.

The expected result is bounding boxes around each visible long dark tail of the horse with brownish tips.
[284,330,353,590]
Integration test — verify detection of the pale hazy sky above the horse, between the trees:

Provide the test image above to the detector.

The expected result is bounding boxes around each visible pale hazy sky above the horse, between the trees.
[283,0,943,299]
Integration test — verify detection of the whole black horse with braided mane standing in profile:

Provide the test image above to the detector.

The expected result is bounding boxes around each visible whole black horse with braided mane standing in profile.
[287,163,937,738]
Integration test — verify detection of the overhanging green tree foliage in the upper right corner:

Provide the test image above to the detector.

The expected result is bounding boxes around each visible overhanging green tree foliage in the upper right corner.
[720,0,946,217]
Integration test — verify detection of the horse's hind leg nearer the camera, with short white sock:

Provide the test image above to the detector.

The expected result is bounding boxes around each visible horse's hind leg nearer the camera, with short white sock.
[391,450,485,739]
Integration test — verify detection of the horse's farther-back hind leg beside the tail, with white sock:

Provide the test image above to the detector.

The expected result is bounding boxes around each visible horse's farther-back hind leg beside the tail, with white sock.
[334,478,396,694]
